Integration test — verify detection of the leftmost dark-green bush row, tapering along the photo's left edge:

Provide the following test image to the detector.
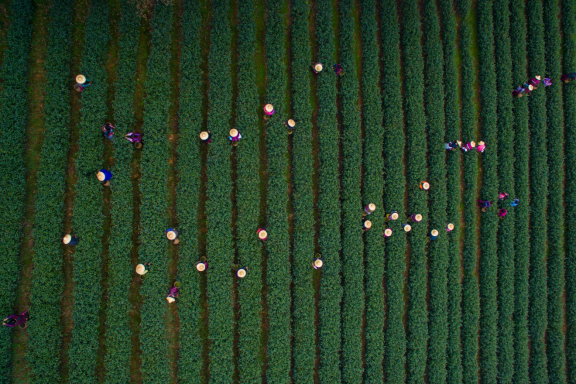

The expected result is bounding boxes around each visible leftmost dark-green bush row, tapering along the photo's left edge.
[0,1,34,382]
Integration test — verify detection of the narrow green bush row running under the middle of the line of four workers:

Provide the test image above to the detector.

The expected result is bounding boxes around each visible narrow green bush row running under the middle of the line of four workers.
[457,0,480,383]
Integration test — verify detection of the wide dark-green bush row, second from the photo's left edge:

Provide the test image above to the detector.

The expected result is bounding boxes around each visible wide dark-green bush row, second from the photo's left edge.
[26,0,74,383]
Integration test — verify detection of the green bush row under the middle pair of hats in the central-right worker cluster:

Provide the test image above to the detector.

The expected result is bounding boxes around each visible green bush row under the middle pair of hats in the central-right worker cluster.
[380,0,406,383]
